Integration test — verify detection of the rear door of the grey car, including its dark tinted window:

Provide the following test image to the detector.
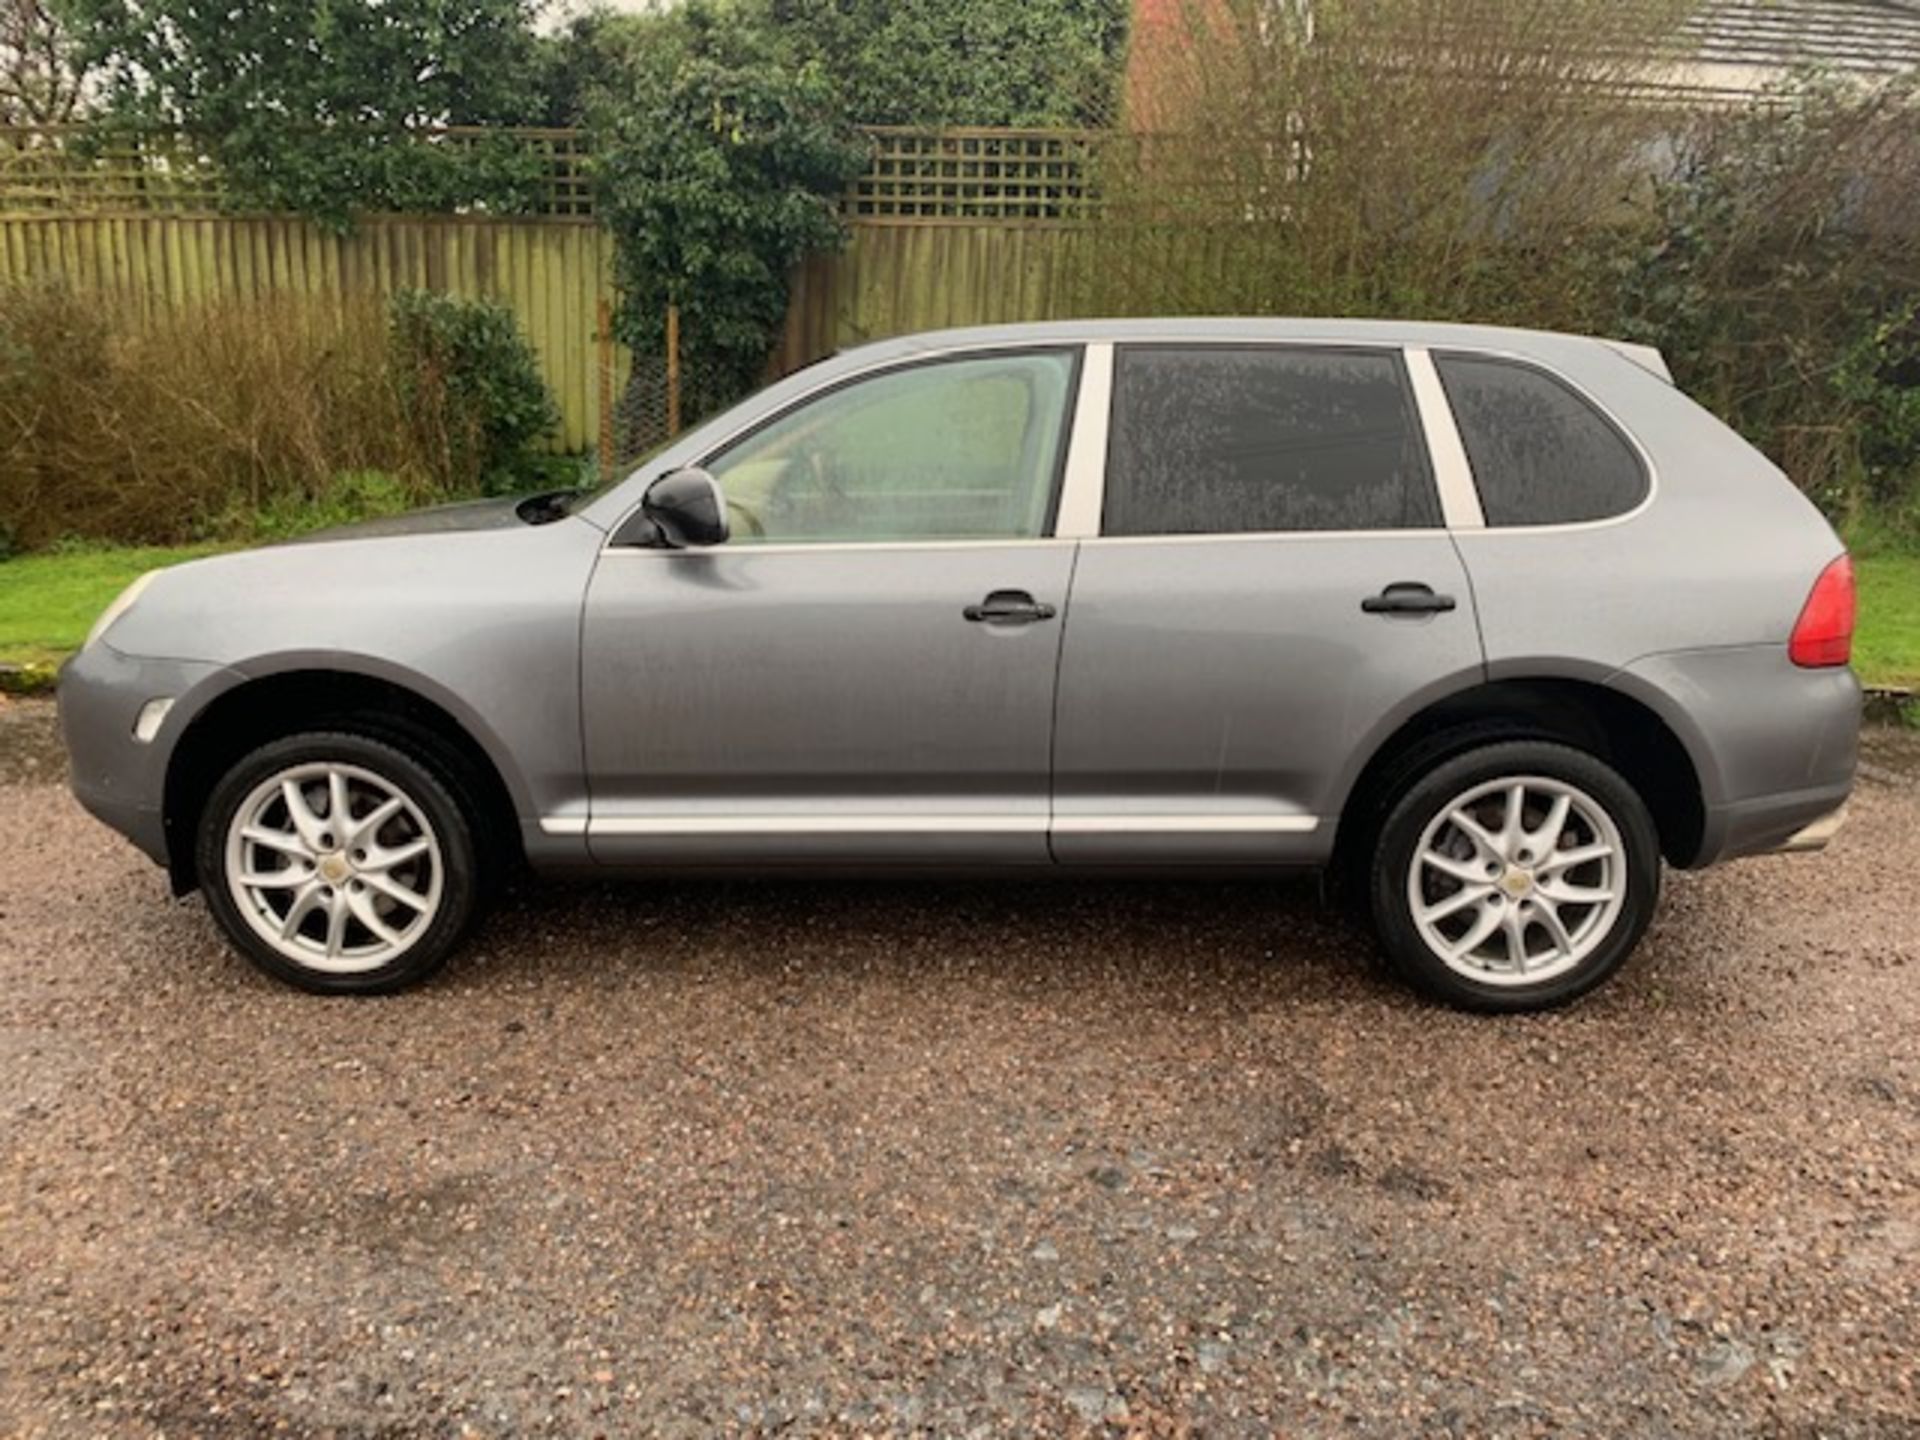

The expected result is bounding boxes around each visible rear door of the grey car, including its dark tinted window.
[1052,344,1484,864]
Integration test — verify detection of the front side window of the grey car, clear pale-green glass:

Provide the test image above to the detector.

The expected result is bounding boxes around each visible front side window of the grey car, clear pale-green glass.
[707,349,1075,545]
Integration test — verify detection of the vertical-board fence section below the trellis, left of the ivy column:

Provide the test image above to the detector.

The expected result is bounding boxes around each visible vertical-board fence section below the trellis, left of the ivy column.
[0,213,612,451]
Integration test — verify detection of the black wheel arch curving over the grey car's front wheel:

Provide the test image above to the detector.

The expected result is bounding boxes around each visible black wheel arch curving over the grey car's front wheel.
[161,655,526,895]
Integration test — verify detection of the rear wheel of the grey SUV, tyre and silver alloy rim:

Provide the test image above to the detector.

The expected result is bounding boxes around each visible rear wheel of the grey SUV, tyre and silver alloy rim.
[1369,741,1661,1010]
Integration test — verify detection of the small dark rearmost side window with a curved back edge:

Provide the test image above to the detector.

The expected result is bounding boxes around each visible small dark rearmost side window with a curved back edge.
[1434,355,1647,524]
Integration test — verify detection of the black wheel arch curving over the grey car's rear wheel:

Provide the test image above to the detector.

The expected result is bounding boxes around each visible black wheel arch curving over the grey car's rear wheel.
[1332,670,1713,881]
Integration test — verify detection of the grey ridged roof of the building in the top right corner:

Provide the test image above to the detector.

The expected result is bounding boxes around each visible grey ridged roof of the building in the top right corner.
[1688,0,1920,73]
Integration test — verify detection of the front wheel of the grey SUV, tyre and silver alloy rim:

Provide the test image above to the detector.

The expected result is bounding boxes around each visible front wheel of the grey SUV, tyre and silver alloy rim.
[196,732,480,995]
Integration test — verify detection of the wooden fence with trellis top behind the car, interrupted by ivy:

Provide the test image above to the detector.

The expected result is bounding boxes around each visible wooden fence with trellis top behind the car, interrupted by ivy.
[0,129,1100,451]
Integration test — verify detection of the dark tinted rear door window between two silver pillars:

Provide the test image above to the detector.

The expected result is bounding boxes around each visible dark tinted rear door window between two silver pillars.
[1102,346,1440,536]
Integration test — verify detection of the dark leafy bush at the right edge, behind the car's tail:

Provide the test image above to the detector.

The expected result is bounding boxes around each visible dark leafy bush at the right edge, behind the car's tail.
[1586,77,1920,516]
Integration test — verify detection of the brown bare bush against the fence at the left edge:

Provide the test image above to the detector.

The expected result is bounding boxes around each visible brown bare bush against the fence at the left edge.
[0,288,430,549]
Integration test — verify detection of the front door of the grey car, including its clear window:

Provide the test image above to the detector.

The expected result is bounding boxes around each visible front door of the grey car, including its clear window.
[584,348,1077,866]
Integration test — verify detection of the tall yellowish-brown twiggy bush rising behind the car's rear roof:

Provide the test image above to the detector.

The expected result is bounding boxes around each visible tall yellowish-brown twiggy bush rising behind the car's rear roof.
[1087,0,1690,323]
